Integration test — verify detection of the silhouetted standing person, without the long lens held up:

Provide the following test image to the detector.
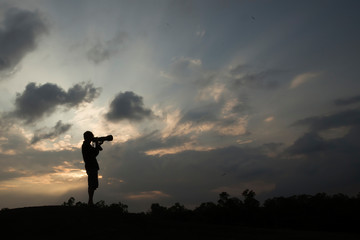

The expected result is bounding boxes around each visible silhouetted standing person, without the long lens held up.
[81,131,101,206]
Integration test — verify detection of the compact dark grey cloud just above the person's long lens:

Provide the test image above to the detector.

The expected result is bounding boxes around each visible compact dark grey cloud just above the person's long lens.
[105,91,153,122]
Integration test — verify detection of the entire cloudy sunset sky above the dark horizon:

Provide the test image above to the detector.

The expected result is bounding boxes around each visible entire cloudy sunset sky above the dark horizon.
[0,0,360,212]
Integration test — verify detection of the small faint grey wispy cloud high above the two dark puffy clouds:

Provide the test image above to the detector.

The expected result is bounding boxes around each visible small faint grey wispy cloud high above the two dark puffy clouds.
[86,32,128,64]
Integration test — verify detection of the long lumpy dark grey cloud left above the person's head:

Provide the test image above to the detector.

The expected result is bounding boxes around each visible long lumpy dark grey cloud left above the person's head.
[9,82,100,124]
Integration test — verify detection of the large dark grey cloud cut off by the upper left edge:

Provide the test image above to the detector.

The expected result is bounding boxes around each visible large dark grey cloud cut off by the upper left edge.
[0,8,48,75]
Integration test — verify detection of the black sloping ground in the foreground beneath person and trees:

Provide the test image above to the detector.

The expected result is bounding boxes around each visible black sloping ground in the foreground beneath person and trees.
[0,206,360,240]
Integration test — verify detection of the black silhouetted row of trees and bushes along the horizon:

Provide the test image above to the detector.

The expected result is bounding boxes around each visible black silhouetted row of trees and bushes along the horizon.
[63,189,360,232]
